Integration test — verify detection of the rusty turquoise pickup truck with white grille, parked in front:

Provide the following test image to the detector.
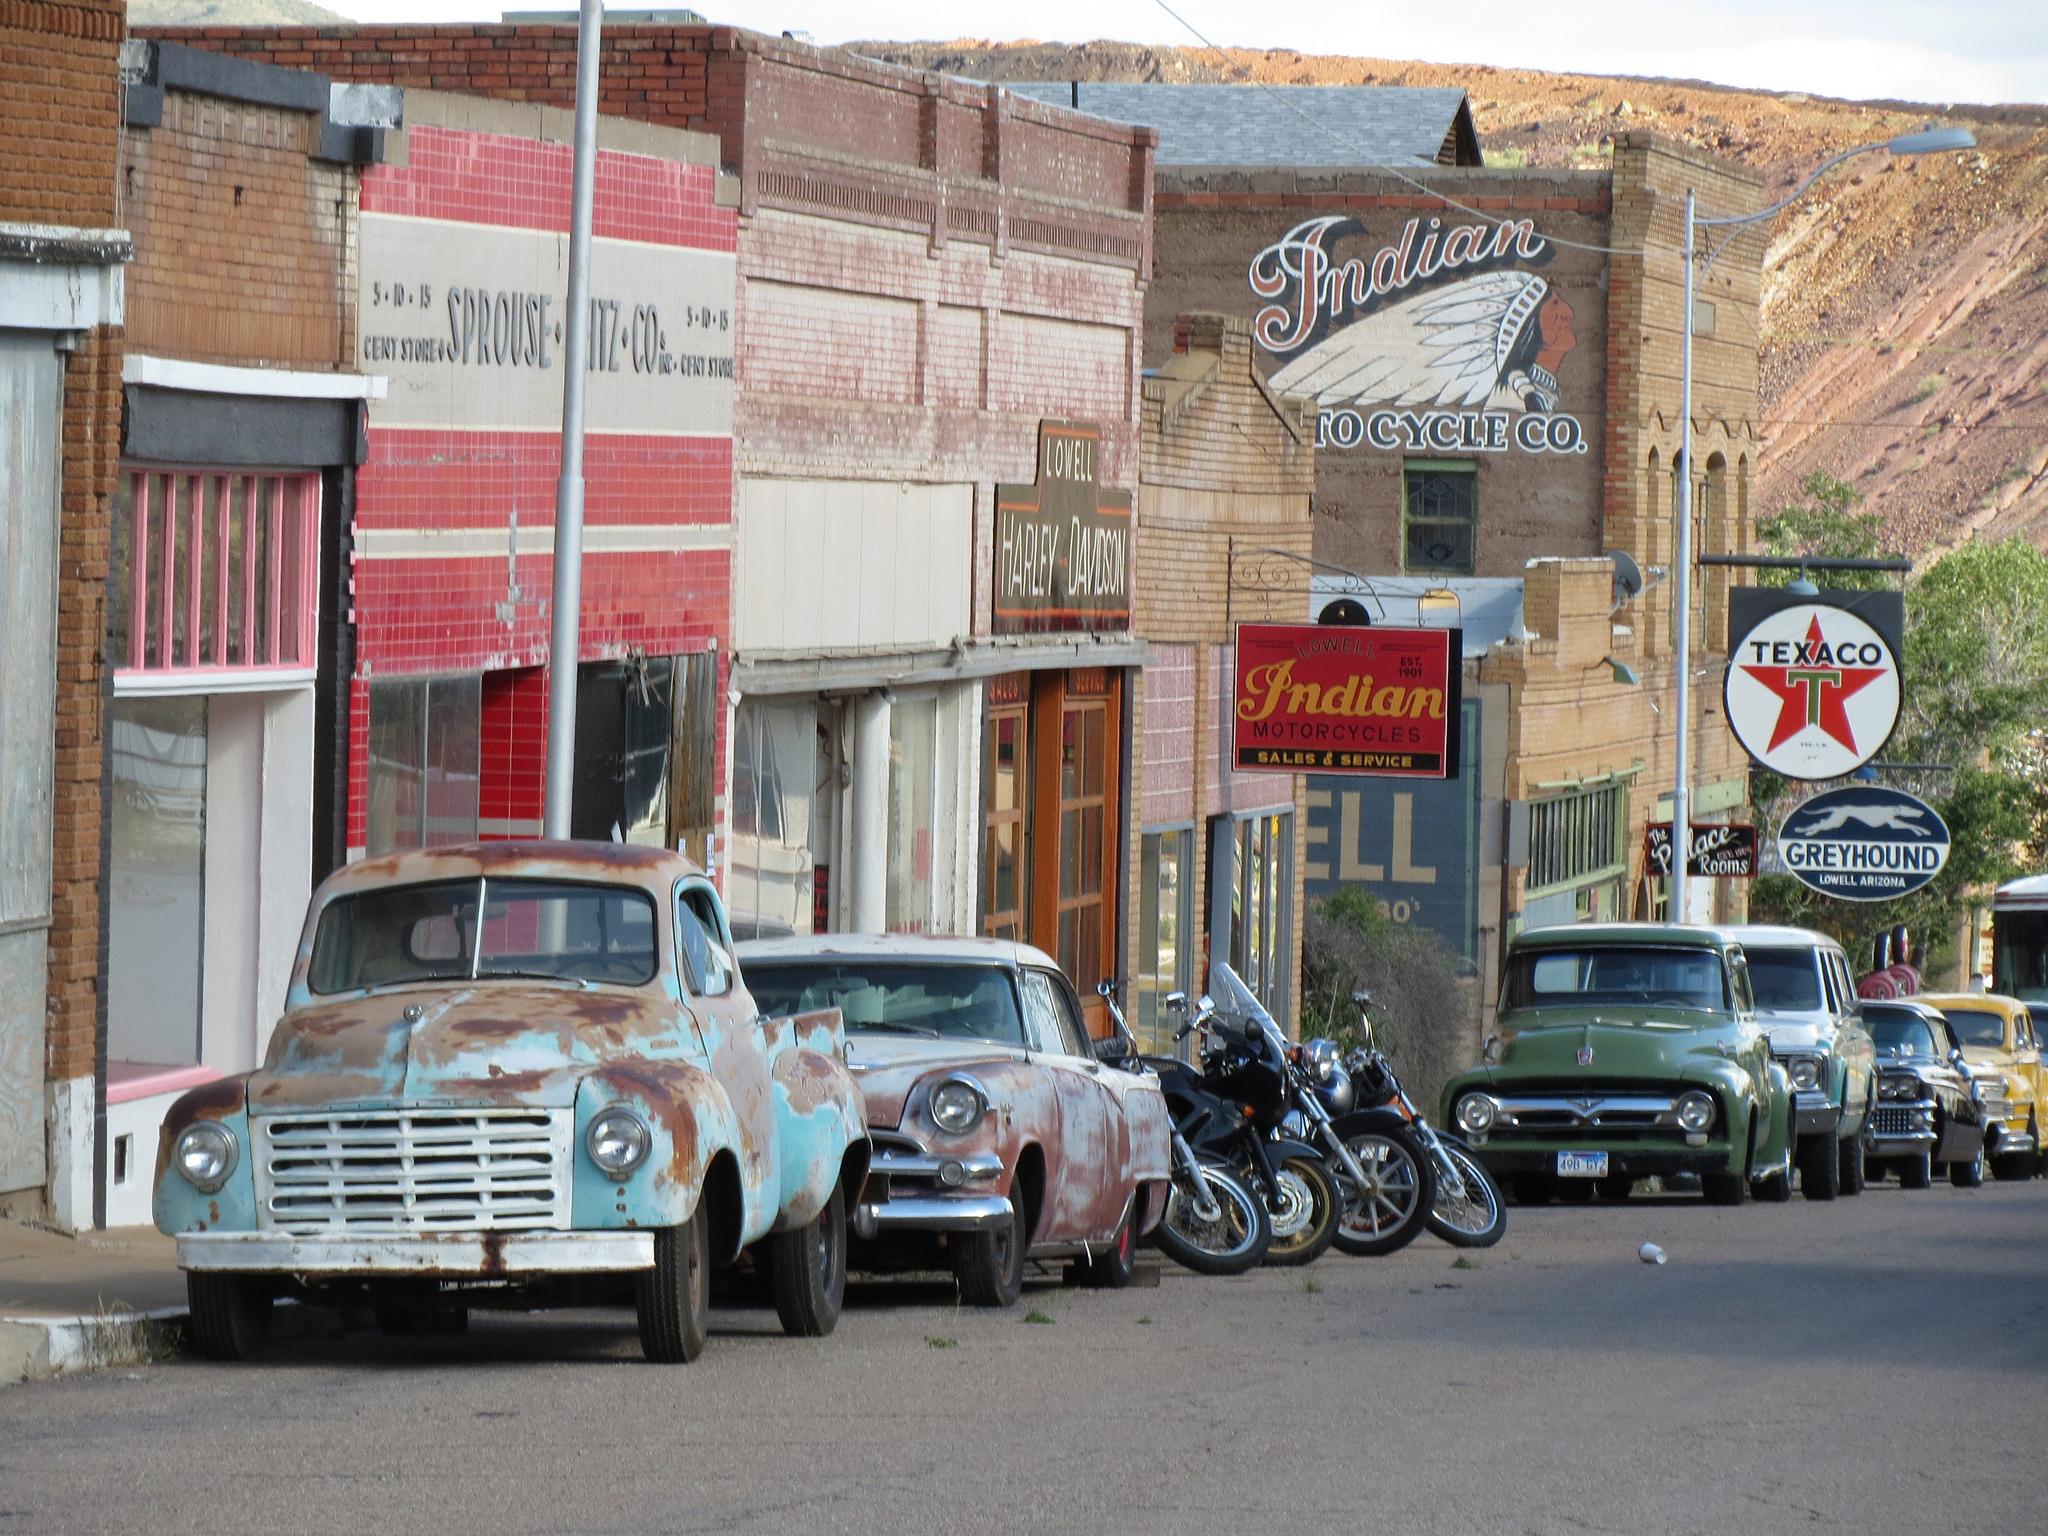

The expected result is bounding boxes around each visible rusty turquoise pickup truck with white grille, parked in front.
[156,842,870,1362]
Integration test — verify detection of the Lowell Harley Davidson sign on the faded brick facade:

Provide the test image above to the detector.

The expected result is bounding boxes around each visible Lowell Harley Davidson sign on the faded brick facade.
[993,422,1130,635]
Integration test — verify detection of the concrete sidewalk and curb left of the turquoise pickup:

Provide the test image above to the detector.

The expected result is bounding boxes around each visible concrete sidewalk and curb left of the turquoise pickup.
[0,1221,184,1384]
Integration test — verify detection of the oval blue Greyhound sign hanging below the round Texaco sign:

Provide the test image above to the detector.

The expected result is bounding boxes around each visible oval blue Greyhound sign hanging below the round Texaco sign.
[1778,784,1948,901]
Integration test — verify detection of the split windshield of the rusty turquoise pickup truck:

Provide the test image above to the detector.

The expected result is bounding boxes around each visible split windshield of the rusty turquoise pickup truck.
[307,879,657,993]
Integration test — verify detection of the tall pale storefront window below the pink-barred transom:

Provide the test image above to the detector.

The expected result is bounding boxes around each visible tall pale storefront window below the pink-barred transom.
[106,696,207,1067]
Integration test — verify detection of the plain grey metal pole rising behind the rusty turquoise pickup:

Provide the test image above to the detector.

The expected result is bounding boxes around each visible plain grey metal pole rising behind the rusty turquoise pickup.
[541,0,604,838]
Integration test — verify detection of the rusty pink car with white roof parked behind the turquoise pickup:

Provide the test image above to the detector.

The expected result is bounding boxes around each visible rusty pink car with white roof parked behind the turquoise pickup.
[739,934,1169,1307]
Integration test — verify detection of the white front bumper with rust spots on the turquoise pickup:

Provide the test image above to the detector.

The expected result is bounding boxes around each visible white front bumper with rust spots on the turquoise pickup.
[178,1231,653,1280]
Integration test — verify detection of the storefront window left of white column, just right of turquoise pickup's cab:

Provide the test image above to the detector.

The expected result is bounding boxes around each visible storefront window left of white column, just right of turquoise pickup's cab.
[725,698,834,938]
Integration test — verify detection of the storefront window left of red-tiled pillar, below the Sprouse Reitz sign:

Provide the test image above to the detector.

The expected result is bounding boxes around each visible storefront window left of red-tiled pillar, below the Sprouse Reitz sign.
[369,676,483,854]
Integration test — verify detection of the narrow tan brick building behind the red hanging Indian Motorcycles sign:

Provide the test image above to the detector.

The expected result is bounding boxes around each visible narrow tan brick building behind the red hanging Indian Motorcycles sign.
[1124,315,1317,1053]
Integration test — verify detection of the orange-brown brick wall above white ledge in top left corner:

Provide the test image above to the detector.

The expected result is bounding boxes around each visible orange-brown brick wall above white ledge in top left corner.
[0,0,127,229]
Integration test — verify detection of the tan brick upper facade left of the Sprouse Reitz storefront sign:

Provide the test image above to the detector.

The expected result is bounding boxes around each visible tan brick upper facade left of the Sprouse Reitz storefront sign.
[121,90,356,371]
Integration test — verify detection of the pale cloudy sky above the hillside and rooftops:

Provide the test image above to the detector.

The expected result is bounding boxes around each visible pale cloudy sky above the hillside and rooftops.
[324,0,2048,104]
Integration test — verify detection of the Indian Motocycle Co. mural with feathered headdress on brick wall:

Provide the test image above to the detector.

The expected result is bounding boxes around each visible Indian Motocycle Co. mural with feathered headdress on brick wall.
[1249,215,1589,453]
